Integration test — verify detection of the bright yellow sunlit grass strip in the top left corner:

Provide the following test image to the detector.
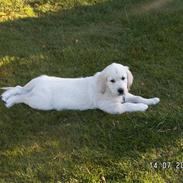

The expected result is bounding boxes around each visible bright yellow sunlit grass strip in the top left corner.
[0,0,106,22]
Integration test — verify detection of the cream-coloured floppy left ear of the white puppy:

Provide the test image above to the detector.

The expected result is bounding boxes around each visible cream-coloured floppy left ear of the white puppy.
[96,72,107,94]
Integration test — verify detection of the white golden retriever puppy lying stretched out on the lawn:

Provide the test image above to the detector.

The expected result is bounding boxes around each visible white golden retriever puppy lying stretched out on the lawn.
[1,63,160,114]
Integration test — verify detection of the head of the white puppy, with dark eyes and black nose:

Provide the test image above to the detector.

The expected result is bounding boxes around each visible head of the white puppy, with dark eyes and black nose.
[97,63,133,96]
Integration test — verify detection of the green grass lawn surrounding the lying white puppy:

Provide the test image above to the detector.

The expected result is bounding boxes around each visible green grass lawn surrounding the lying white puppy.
[0,0,183,183]
